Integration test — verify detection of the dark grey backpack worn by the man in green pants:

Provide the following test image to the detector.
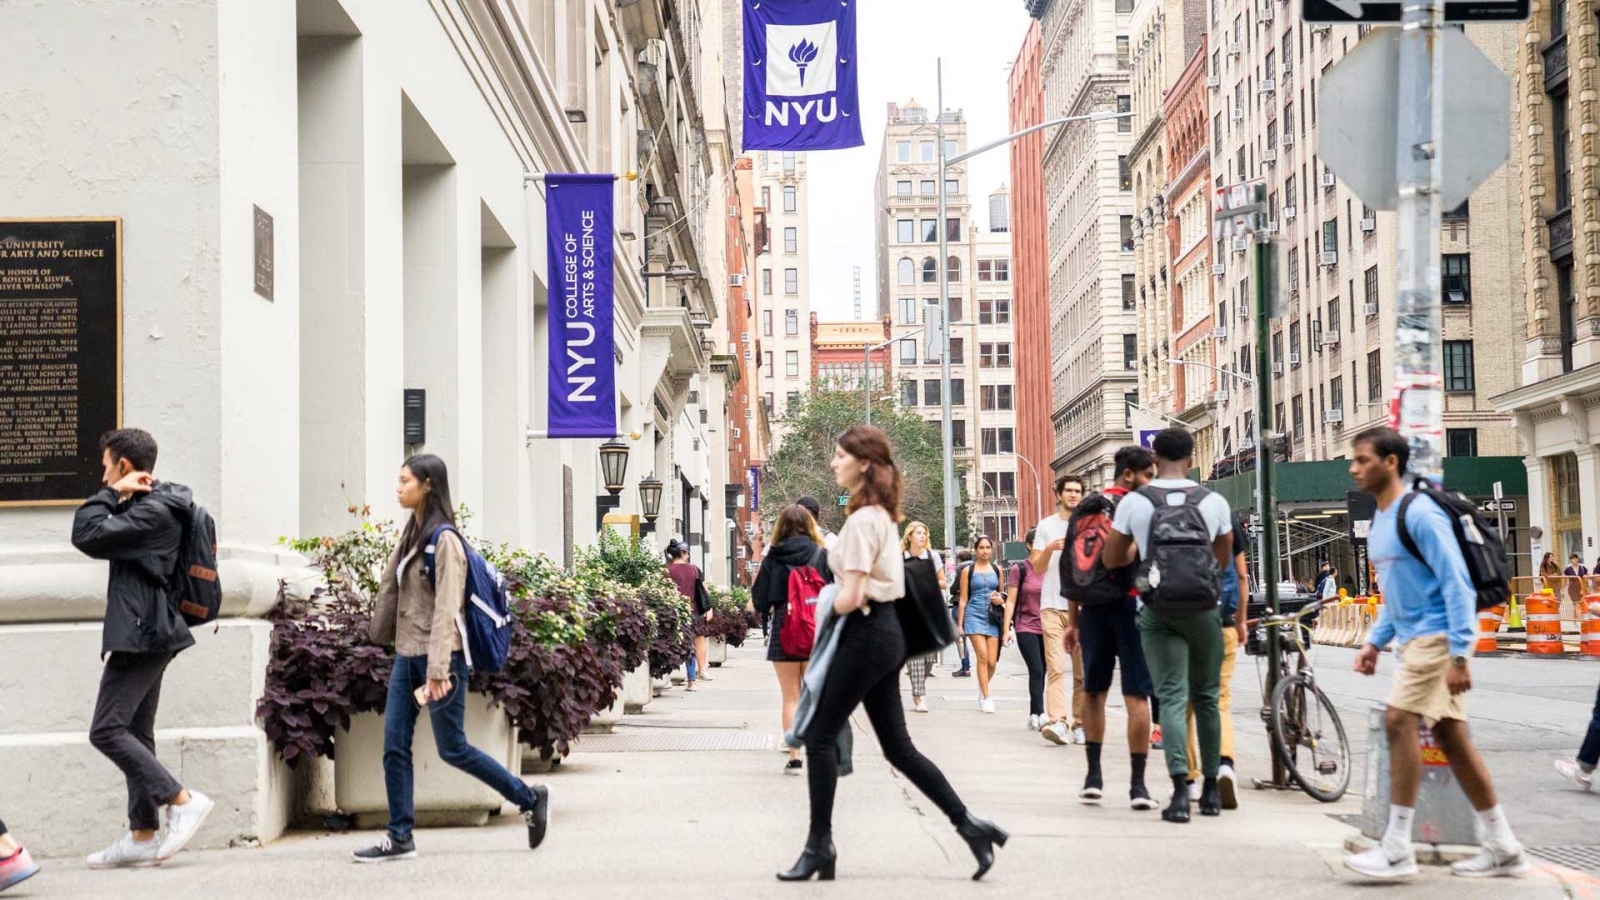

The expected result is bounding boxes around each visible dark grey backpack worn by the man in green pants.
[1138,485,1222,615]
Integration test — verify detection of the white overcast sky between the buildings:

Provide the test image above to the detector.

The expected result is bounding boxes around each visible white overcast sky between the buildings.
[806,0,1027,320]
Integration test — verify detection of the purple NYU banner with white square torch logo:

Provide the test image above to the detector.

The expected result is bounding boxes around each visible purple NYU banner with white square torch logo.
[744,0,864,151]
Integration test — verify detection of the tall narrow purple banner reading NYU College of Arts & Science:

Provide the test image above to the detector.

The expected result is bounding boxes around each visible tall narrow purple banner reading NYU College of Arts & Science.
[544,175,616,439]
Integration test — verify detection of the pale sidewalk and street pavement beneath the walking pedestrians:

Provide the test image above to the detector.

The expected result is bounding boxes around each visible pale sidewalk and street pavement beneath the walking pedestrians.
[14,634,1600,900]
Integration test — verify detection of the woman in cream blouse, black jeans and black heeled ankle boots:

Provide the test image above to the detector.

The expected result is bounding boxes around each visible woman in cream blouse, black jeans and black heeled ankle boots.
[778,424,1008,881]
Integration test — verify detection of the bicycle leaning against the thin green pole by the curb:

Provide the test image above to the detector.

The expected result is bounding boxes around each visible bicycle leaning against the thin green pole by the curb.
[1246,601,1350,802]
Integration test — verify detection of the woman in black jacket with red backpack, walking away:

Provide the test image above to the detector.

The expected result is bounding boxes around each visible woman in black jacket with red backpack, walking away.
[750,504,829,775]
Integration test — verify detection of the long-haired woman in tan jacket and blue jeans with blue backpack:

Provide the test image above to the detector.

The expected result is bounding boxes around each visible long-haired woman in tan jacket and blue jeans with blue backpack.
[354,453,550,863]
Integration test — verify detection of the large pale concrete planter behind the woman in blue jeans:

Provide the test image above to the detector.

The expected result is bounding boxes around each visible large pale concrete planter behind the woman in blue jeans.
[334,693,522,828]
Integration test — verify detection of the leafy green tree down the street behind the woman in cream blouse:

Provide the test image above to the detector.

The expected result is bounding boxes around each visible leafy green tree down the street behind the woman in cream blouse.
[760,384,971,546]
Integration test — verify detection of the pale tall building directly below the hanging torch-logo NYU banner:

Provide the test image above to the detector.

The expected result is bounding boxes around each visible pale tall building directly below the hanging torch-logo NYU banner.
[752,151,811,447]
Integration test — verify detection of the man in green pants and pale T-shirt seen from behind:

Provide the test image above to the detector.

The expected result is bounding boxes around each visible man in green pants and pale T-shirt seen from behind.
[1102,428,1234,823]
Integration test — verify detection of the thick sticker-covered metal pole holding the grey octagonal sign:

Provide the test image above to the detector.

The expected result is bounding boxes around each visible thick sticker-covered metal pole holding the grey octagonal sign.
[1389,0,1445,487]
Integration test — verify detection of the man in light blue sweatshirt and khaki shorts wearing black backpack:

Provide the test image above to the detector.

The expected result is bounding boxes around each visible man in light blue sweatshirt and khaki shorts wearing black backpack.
[1344,428,1530,879]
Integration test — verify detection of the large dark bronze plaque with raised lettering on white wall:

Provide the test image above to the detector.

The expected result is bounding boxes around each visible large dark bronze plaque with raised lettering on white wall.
[0,218,122,506]
